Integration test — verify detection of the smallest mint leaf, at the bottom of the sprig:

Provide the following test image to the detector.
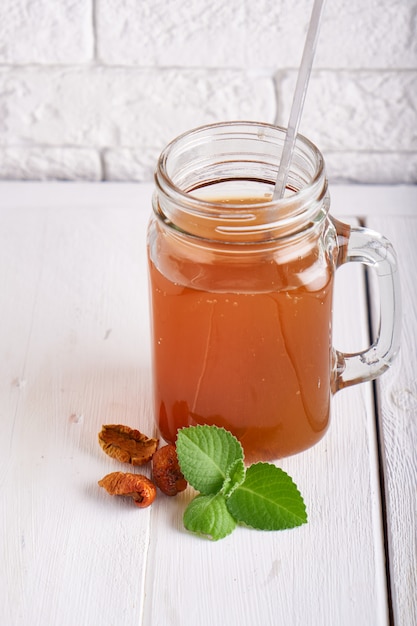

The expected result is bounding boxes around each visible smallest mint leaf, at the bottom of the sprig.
[184,494,236,541]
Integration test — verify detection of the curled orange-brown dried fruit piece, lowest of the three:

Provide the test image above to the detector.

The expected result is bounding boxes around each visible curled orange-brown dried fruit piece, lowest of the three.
[98,472,156,509]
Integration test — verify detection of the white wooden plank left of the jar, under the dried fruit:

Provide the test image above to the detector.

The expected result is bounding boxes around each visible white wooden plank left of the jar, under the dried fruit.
[0,199,153,626]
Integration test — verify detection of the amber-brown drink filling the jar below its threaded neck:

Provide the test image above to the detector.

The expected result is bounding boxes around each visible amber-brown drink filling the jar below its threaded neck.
[150,193,332,462]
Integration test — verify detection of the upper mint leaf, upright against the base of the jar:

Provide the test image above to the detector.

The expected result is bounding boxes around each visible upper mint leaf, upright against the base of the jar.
[176,425,243,495]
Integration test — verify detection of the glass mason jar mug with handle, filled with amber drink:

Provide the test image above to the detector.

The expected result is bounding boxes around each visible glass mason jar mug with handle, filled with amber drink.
[148,122,399,461]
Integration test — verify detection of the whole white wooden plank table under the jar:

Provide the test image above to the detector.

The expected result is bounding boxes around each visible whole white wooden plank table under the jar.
[0,183,417,626]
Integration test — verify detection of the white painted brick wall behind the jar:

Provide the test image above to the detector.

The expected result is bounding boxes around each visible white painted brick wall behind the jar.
[0,0,417,183]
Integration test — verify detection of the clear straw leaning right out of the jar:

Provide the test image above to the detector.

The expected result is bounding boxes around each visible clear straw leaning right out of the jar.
[274,0,325,200]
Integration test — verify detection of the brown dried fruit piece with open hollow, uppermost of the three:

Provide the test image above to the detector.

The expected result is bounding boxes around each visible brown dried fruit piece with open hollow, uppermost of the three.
[98,424,158,465]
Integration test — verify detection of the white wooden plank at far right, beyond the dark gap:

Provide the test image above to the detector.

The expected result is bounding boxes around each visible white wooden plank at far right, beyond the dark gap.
[367,216,417,626]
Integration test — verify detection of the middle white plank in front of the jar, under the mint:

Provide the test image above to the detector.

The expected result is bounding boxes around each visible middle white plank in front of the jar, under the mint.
[144,390,388,626]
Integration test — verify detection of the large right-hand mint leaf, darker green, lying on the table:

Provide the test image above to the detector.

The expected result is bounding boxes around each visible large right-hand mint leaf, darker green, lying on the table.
[226,463,307,530]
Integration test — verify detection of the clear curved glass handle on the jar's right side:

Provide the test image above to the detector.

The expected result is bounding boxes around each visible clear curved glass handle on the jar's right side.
[332,218,401,392]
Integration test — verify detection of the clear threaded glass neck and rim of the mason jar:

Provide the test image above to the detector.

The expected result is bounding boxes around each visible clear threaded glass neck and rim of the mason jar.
[154,121,328,242]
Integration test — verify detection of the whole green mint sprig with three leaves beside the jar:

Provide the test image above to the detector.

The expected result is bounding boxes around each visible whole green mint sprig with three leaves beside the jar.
[176,426,307,540]
